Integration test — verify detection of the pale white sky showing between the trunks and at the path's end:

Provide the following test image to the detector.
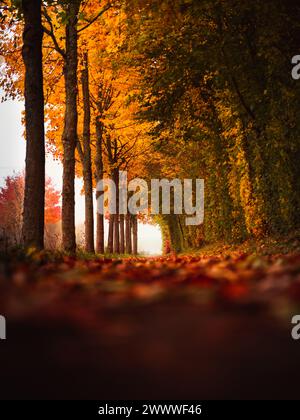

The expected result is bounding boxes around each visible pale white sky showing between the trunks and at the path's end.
[0,101,162,255]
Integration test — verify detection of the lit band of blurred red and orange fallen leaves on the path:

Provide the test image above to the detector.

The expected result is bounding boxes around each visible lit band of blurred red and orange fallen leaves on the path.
[0,251,300,321]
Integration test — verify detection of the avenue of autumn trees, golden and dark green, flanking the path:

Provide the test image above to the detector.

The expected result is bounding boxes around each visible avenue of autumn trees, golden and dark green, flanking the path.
[0,0,300,254]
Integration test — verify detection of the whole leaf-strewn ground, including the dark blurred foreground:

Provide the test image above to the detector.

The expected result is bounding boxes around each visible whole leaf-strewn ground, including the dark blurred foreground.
[0,251,300,400]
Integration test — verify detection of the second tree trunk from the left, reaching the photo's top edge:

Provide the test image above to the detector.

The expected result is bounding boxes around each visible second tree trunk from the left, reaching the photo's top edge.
[62,0,81,253]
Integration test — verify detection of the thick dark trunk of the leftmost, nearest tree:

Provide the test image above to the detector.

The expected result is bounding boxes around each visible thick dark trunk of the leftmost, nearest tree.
[22,0,45,249]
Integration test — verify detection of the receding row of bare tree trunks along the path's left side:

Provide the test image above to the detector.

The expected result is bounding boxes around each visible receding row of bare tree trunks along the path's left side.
[22,0,138,254]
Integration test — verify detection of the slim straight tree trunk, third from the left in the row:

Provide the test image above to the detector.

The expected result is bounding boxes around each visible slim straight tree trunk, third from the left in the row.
[81,49,95,253]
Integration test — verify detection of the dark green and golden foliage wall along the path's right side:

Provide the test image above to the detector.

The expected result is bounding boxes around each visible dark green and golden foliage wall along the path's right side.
[126,0,300,250]
